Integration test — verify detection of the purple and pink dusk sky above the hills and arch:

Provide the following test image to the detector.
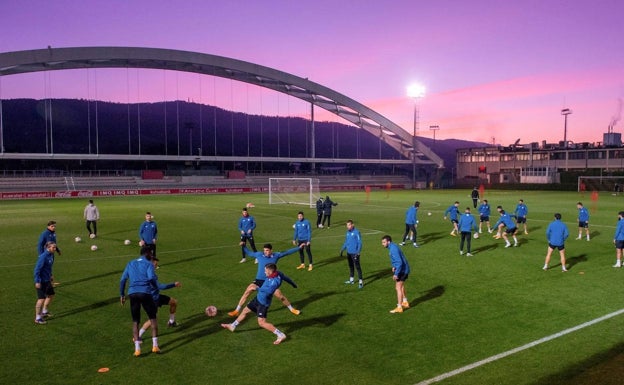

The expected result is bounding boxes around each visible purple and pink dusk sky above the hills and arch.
[0,0,624,145]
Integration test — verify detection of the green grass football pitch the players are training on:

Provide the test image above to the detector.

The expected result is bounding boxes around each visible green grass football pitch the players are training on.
[0,190,624,384]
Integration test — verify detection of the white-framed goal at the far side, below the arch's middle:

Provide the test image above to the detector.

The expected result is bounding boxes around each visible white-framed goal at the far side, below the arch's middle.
[269,178,321,207]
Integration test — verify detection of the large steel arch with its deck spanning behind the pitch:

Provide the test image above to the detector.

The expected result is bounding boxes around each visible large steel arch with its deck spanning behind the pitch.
[0,47,444,167]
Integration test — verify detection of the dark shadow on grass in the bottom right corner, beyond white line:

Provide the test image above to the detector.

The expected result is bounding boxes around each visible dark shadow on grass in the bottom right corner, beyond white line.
[534,343,624,385]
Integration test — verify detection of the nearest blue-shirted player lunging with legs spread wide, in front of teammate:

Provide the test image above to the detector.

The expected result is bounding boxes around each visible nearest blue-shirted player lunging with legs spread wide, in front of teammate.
[221,263,287,345]
